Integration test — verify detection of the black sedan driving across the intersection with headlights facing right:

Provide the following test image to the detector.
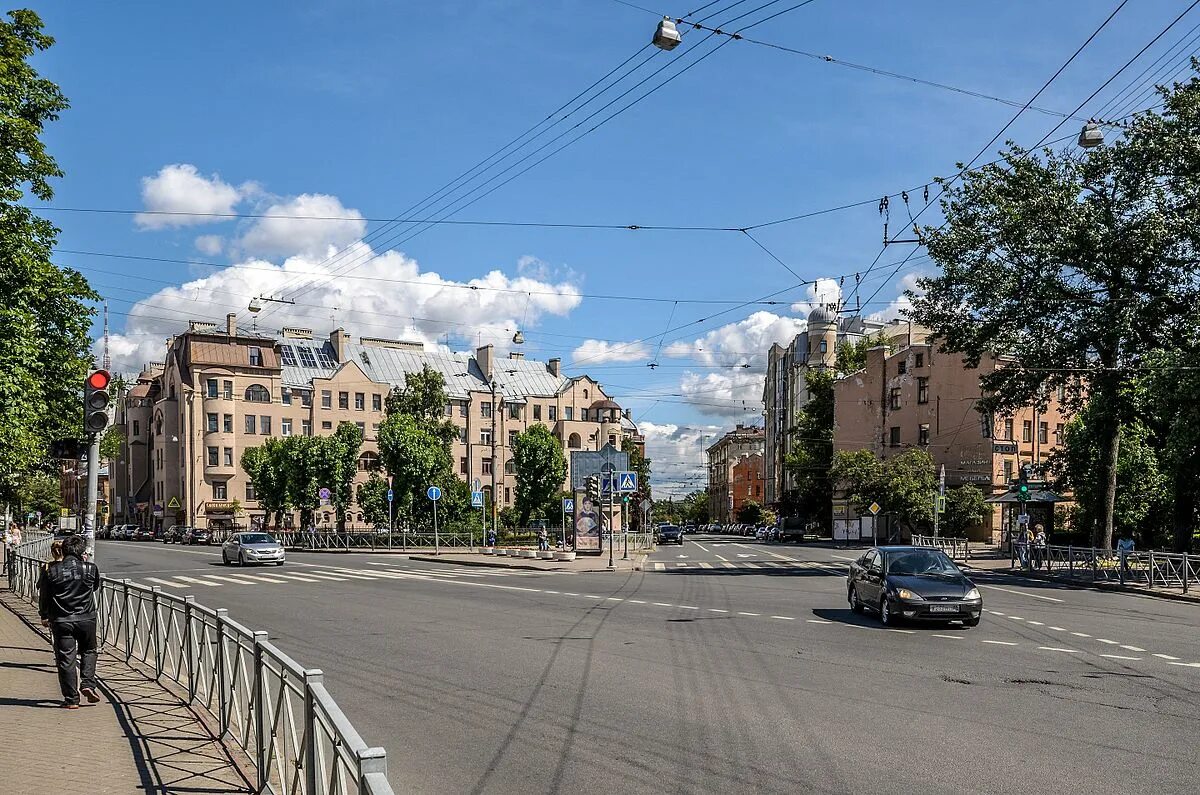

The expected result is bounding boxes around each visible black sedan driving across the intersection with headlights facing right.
[846,546,983,627]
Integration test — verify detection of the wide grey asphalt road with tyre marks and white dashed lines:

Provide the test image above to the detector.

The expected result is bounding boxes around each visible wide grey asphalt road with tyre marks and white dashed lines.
[97,537,1200,794]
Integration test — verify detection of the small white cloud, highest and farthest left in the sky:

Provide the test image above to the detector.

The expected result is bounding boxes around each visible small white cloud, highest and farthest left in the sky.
[133,163,241,229]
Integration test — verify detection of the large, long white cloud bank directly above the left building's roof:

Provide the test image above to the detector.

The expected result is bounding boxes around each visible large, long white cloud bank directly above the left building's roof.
[110,244,582,371]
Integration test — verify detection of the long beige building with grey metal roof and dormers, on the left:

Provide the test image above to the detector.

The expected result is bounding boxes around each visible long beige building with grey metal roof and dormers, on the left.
[118,315,642,527]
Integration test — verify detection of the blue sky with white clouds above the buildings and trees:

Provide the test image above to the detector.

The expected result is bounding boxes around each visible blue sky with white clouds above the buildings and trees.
[21,0,1200,497]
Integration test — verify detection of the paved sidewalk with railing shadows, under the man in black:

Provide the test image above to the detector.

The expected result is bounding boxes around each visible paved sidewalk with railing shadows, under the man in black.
[0,587,250,795]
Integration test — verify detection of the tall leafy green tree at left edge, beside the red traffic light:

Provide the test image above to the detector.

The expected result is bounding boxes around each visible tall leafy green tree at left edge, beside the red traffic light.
[0,10,98,485]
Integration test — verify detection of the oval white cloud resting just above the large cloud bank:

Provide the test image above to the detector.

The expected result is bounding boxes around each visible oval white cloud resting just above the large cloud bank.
[238,193,367,257]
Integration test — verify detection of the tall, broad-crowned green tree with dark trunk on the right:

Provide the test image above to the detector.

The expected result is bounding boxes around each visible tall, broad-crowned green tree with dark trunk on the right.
[910,79,1200,554]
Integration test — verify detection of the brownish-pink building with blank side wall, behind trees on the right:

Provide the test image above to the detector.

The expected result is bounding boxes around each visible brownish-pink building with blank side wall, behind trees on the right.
[833,342,1068,540]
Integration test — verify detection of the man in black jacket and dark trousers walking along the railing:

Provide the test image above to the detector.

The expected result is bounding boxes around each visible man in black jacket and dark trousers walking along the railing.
[37,536,100,710]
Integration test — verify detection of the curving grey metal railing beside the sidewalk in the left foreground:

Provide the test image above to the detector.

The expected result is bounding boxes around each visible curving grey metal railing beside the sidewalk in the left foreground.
[8,536,392,795]
